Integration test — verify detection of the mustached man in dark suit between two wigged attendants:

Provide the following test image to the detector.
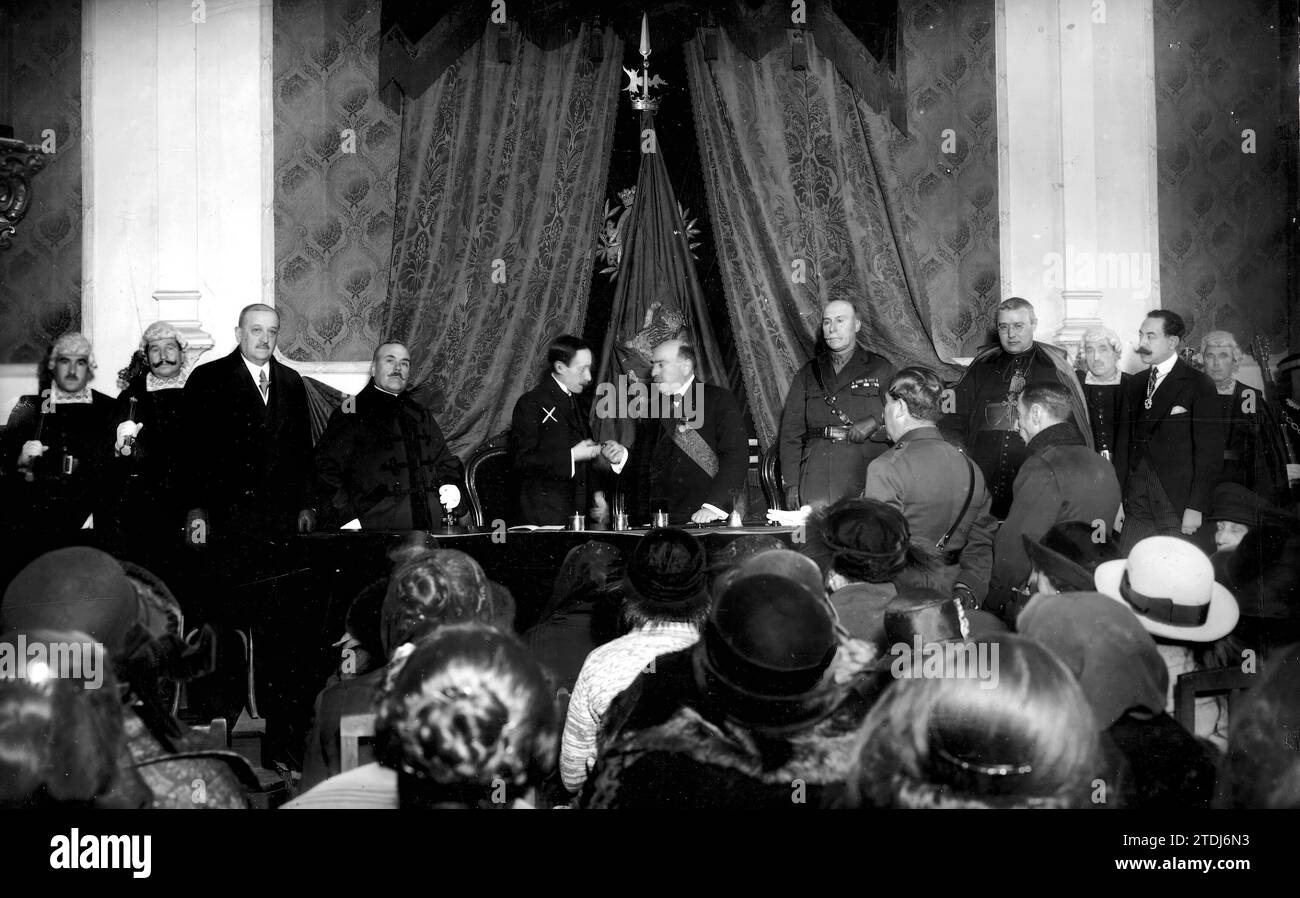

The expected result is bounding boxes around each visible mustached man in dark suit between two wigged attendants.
[1115,309,1223,554]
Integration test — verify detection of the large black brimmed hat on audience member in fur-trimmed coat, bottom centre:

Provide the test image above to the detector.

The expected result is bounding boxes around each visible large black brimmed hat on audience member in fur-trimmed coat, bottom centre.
[692,573,845,734]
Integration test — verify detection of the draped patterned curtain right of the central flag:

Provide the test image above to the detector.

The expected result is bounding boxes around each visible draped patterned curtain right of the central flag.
[686,23,956,446]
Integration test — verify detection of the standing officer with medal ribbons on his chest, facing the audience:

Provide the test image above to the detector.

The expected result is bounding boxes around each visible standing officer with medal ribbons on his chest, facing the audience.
[780,300,893,508]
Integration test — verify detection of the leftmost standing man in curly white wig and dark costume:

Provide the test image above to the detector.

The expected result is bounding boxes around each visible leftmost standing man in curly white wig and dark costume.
[0,333,116,534]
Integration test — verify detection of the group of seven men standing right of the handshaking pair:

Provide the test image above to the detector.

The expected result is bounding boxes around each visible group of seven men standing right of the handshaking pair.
[780,298,1300,618]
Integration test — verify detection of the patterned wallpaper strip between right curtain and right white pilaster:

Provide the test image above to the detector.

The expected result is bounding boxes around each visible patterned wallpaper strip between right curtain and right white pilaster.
[891,0,1001,359]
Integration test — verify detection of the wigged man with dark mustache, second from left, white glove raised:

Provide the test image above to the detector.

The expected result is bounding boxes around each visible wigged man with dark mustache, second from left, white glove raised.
[107,321,190,548]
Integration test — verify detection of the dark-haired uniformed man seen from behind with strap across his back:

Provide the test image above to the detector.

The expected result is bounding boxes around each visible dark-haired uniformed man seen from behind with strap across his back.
[863,368,997,608]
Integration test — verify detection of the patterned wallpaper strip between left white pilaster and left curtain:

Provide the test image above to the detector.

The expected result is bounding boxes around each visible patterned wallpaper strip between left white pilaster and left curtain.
[272,0,400,361]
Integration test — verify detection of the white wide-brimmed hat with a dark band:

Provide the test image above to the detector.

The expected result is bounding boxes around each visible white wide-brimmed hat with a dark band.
[1093,537,1240,642]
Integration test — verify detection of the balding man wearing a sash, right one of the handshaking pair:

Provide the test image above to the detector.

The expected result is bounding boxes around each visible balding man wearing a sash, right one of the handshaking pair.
[631,339,749,524]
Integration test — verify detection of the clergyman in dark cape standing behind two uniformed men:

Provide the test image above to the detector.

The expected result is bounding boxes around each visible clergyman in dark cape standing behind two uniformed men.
[940,296,1092,520]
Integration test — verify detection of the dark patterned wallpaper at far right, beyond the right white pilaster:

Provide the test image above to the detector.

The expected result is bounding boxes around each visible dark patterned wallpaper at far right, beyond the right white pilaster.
[1154,0,1296,350]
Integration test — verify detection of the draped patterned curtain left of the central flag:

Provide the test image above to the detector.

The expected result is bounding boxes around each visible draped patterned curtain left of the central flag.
[385,25,623,457]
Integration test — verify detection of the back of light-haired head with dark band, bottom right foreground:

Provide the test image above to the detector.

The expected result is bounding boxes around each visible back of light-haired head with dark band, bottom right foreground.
[850,634,1100,807]
